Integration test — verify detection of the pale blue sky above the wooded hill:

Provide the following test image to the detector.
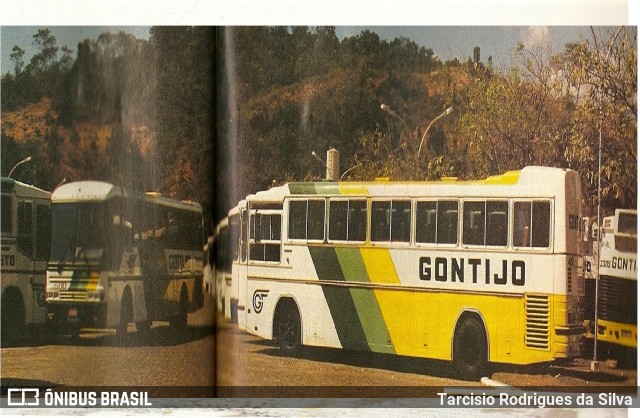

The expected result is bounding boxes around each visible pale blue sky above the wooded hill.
[0,26,591,74]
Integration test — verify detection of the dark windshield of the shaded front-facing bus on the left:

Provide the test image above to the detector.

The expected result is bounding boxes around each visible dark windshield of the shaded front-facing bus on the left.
[50,203,107,264]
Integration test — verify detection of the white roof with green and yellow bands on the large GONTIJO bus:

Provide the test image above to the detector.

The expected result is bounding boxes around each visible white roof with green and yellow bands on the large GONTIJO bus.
[247,166,578,201]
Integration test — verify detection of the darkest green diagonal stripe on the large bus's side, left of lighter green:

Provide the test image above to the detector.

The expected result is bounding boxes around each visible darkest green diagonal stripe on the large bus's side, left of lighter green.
[309,247,370,351]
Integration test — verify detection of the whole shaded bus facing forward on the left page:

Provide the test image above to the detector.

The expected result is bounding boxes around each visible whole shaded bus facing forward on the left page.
[46,181,203,334]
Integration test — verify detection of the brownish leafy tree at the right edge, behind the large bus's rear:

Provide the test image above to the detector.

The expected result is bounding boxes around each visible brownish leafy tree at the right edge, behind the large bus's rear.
[558,27,638,211]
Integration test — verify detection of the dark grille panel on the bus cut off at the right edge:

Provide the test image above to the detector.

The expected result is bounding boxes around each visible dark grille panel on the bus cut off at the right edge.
[598,276,638,324]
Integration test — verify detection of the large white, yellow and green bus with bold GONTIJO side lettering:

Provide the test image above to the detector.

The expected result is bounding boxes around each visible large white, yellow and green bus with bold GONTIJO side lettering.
[239,167,584,378]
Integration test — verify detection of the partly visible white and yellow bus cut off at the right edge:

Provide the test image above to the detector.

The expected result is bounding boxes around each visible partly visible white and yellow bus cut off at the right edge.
[589,209,638,359]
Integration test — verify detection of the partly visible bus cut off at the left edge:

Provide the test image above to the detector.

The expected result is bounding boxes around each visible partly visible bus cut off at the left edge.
[0,177,51,345]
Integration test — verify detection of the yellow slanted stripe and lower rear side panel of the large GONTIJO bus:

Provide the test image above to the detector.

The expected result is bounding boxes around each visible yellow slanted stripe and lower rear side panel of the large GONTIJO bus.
[360,248,567,364]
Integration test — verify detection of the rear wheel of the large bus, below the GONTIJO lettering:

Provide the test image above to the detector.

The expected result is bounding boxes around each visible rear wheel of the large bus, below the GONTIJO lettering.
[453,318,488,380]
